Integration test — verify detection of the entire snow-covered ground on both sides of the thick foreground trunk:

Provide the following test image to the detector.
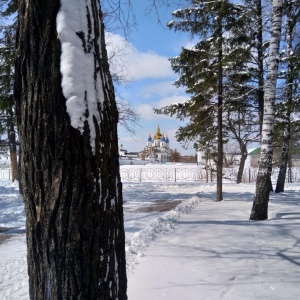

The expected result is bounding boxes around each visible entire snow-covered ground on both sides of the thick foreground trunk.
[0,165,300,300]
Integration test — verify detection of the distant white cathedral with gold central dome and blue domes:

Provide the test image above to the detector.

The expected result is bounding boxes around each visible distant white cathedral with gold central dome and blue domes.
[144,125,170,163]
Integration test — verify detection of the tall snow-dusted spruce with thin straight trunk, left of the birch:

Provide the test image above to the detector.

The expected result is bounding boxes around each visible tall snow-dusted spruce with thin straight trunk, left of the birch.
[156,1,250,201]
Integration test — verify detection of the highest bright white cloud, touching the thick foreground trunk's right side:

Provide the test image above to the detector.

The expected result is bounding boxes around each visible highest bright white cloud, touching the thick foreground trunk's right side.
[106,33,174,80]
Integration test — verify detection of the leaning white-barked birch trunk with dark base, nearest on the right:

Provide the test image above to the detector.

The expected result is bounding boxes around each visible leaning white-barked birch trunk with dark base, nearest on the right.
[250,0,282,220]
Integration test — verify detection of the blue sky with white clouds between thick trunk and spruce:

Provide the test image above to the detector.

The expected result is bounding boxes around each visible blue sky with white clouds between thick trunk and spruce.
[108,0,195,155]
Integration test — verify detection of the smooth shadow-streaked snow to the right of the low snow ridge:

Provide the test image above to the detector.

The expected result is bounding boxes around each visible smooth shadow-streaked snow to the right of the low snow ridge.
[128,185,300,300]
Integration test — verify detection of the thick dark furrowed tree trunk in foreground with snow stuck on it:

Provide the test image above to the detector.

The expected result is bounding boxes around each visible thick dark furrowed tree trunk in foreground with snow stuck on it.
[15,0,127,300]
